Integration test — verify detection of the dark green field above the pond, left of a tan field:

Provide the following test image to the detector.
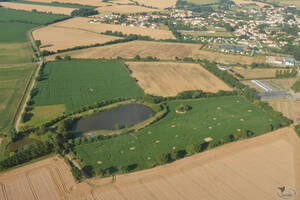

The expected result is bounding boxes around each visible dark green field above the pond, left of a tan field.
[33,60,143,112]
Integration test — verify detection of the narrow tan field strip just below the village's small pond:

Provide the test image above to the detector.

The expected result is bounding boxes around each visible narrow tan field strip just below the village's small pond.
[194,50,266,65]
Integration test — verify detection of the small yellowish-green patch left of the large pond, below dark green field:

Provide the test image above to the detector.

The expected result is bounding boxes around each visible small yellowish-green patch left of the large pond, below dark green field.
[25,104,65,127]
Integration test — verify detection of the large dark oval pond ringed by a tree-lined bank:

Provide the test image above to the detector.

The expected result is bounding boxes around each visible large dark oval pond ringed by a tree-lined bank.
[74,104,154,133]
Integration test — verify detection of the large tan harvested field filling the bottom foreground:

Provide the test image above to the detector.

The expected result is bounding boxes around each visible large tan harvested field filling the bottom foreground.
[0,127,300,200]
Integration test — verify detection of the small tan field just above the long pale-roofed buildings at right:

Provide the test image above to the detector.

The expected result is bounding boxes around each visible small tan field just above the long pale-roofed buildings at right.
[233,67,278,79]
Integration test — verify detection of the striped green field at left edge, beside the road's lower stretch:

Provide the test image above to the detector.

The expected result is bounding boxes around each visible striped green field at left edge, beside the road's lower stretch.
[0,64,34,131]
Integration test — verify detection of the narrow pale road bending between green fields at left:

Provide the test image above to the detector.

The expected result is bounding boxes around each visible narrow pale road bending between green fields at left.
[15,30,44,131]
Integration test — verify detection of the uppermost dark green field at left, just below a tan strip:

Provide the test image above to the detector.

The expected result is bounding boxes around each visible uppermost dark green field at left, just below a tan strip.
[0,8,67,24]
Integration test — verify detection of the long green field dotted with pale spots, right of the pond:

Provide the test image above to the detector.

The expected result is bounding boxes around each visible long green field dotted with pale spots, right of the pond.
[74,97,279,173]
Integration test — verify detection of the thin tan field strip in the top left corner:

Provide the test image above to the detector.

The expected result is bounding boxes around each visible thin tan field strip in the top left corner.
[0,2,75,15]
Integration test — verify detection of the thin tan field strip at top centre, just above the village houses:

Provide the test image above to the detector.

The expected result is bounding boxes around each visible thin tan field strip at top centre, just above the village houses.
[96,5,158,14]
